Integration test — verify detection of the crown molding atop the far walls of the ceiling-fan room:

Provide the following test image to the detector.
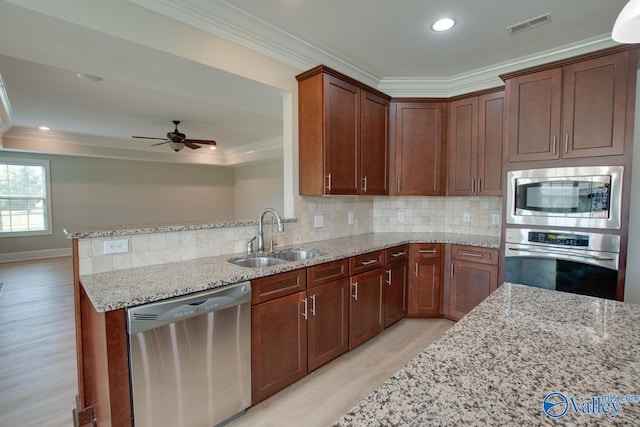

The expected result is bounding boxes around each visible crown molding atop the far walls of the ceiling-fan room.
[2,127,282,166]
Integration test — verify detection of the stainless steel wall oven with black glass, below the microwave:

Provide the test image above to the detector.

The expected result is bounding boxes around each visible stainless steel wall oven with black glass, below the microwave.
[504,228,620,299]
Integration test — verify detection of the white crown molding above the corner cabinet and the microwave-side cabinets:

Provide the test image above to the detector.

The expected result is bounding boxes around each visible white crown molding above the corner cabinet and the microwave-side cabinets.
[378,34,618,98]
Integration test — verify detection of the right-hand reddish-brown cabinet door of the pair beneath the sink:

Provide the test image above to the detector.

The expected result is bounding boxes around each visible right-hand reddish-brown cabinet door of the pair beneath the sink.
[307,279,349,371]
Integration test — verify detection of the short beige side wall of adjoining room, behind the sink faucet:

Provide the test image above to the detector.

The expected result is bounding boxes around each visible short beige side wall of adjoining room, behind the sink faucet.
[234,158,284,220]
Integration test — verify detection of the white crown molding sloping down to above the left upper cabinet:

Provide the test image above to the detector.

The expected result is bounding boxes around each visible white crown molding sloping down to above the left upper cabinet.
[129,0,382,87]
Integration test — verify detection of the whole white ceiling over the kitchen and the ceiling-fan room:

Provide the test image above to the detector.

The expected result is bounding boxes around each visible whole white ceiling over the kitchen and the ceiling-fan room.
[0,0,626,164]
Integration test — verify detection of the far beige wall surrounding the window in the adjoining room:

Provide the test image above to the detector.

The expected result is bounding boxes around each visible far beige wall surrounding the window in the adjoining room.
[0,151,235,254]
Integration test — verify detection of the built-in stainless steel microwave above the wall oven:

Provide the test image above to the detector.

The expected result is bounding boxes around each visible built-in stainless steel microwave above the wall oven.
[506,166,623,229]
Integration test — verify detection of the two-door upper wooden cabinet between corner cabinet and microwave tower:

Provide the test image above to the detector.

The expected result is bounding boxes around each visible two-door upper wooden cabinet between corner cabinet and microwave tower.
[447,91,504,196]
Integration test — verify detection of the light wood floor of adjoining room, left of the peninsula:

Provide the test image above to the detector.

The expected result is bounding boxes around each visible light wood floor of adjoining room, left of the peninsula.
[0,257,77,427]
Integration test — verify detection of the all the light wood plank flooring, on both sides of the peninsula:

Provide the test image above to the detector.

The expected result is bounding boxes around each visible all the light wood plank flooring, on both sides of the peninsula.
[0,257,454,427]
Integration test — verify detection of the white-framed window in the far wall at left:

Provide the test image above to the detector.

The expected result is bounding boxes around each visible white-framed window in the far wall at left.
[0,159,52,237]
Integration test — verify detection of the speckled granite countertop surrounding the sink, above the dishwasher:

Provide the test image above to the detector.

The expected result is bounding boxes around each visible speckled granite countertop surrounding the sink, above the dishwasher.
[80,233,500,312]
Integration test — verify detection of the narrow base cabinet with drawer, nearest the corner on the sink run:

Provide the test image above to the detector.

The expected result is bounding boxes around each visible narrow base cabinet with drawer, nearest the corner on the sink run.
[382,245,408,328]
